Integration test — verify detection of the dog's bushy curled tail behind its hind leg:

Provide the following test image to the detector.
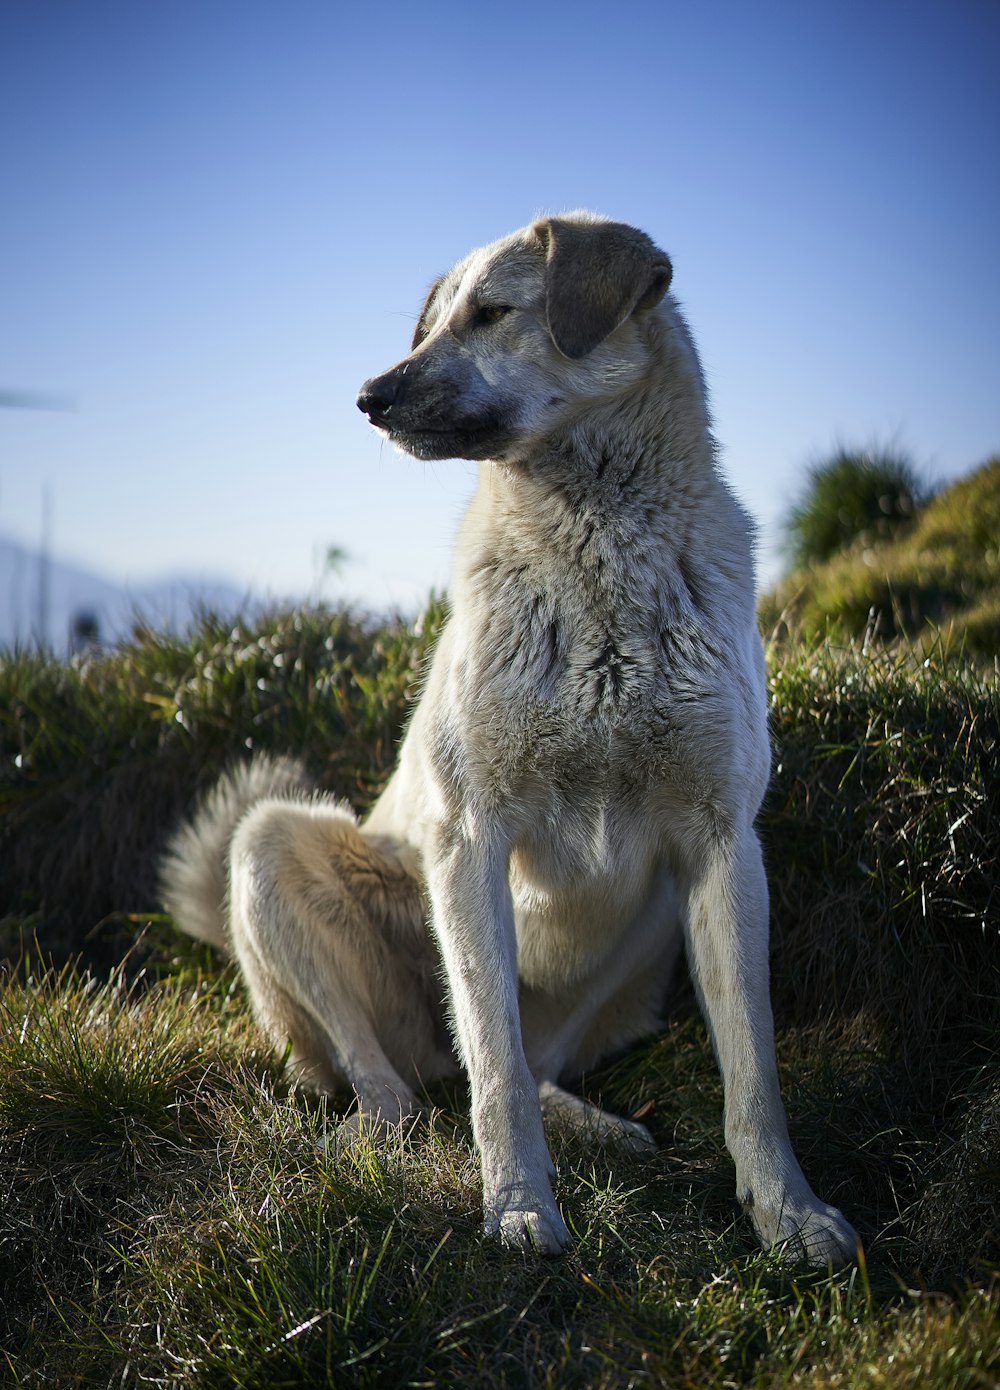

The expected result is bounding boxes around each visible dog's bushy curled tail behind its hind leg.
[160,753,313,954]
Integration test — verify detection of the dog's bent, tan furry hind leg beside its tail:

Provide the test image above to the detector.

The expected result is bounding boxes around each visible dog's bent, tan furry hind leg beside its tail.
[229,798,453,1127]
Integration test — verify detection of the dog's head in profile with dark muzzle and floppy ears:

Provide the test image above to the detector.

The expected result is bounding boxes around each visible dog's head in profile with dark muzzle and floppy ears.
[357,213,670,459]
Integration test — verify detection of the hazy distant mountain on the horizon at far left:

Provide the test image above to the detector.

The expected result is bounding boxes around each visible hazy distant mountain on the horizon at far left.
[0,537,255,653]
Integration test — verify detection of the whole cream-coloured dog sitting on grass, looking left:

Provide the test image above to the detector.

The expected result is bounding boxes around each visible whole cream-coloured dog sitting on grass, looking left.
[161,213,858,1265]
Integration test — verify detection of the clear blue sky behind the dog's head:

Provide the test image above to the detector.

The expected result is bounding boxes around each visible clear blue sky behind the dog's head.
[0,0,1000,607]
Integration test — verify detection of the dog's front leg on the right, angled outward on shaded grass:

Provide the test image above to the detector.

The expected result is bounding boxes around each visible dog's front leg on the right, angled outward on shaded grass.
[687,826,858,1265]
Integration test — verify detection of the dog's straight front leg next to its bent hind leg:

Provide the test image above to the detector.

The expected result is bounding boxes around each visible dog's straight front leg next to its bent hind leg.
[427,835,569,1255]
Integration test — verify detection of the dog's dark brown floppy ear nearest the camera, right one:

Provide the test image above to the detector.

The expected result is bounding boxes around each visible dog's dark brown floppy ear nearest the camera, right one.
[533,217,673,357]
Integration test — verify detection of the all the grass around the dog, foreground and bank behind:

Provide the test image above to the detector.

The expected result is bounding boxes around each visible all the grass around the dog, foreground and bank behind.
[0,603,1000,1390]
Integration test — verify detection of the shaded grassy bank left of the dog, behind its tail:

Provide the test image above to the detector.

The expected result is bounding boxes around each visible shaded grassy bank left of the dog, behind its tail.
[0,599,444,970]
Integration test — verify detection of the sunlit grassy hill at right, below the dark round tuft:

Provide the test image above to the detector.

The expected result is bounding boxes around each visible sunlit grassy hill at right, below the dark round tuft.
[761,457,1000,664]
